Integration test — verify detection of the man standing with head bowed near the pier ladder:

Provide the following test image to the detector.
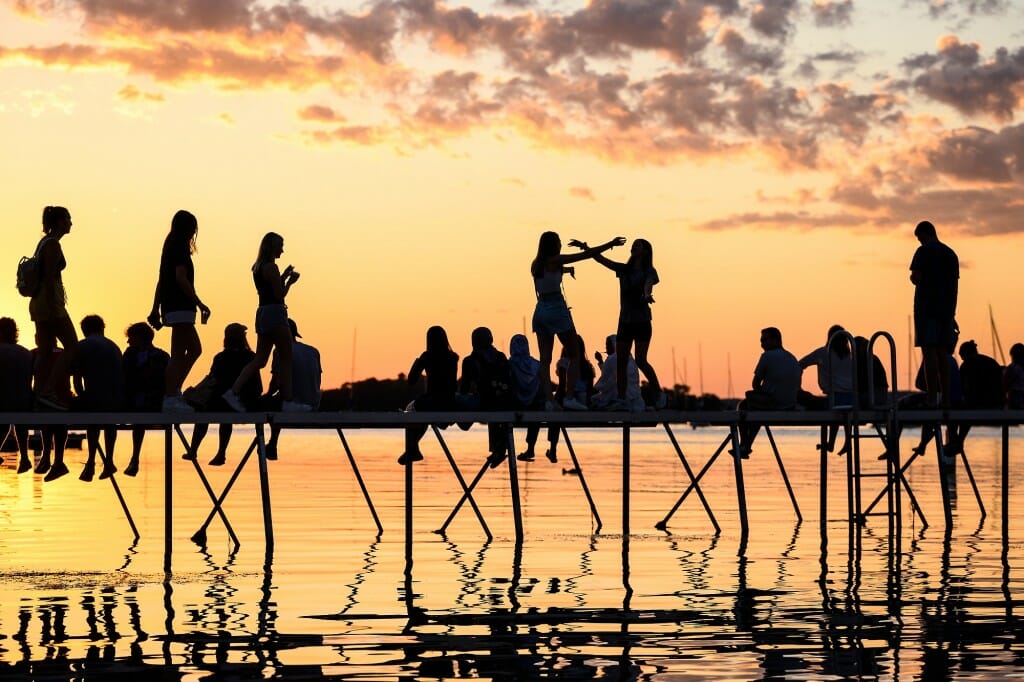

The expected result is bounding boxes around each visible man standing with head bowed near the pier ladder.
[910,220,959,408]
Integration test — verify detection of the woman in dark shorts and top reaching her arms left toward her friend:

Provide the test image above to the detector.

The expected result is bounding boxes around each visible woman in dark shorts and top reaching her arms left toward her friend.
[569,240,667,410]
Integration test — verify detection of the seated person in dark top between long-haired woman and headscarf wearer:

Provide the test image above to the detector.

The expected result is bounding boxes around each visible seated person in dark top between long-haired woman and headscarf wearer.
[459,327,512,468]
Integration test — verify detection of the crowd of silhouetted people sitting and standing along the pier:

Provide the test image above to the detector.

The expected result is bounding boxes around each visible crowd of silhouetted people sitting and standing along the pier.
[0,206,1024,480]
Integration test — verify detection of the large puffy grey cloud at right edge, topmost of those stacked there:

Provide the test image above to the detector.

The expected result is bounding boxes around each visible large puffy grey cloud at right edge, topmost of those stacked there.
[903,37,1024,121]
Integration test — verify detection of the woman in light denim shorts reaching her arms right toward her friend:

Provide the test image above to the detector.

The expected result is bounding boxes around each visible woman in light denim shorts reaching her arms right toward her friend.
[529,230,626,410]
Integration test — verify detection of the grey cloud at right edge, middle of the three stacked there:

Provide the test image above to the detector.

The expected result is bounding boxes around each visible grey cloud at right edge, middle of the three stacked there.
[928,124,1024,180]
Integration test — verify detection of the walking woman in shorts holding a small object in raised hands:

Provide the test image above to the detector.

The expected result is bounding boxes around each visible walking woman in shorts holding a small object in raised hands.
[222,232,311,412]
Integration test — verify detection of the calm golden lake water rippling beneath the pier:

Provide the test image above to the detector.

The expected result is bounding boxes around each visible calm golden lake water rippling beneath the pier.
[0,426,1024,680]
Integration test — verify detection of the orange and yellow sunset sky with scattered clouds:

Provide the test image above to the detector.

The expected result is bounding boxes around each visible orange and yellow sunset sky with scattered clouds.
[0,0,1024,394]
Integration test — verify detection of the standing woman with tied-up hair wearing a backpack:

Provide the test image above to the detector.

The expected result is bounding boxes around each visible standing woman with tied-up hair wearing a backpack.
[29,206,78,410]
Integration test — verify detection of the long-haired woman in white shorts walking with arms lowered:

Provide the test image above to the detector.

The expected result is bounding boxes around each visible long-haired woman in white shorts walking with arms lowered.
[147,211,210,413]
